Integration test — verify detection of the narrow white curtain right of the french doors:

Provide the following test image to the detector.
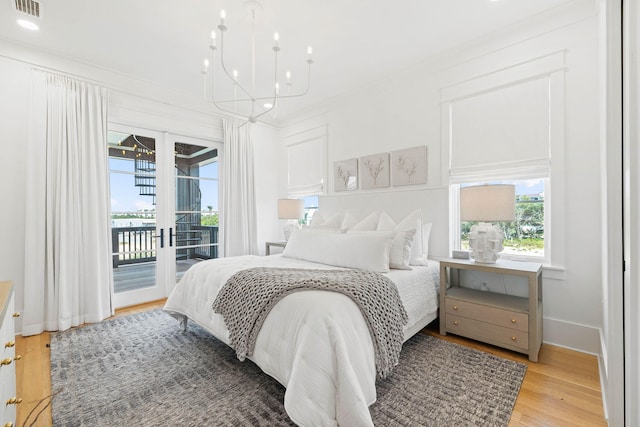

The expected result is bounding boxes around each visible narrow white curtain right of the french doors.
[220,119,258,257]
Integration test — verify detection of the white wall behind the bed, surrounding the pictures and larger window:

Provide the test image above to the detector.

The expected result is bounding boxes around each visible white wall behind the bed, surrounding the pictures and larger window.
[283,2,602,353]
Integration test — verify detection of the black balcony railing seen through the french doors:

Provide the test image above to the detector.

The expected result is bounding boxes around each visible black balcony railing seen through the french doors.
[111,225,218,268]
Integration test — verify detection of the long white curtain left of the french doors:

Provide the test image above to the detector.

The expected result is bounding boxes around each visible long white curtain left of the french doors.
[22,70,113,335]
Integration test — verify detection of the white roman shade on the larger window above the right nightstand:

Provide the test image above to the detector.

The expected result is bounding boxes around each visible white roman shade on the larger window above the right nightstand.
[450,78,550,183]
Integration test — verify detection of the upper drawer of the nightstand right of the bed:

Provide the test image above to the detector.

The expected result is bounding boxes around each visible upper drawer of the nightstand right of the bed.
[446,298,529,332]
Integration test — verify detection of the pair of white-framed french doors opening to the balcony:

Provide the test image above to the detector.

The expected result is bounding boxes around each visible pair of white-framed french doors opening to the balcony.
[108,124,222,308]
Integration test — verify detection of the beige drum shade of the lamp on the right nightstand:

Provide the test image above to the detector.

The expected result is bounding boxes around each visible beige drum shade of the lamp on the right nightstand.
[460,184,516,222]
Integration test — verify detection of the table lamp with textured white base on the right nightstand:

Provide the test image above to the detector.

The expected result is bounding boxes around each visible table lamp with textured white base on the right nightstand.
[460,184,516,264]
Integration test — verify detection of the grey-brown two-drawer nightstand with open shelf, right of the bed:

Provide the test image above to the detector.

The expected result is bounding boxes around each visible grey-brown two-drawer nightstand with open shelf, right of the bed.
[440,259,542,362]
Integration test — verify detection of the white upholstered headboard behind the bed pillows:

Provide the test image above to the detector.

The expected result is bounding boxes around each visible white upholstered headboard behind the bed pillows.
[319,188,449,258]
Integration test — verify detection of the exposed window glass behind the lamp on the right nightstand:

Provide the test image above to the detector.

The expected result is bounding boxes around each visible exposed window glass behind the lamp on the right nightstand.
[452,178,548,260]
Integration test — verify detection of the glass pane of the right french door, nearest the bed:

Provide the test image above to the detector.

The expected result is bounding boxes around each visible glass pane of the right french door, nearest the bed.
[173,142,219,281]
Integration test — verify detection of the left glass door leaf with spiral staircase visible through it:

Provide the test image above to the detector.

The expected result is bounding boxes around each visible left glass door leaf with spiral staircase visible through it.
[108,131,160,307]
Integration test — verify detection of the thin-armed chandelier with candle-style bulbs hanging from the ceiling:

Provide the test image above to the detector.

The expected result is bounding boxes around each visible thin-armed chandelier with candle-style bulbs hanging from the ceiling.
[202,0,313,126]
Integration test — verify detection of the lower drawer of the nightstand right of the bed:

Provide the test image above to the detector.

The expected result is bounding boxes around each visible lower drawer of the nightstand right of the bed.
[447,313,529,351]
